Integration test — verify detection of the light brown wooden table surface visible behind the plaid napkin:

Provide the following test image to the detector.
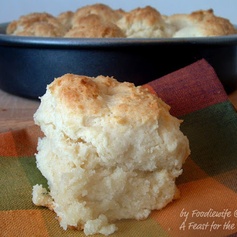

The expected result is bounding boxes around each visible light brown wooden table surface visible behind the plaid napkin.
[0,90,237,132]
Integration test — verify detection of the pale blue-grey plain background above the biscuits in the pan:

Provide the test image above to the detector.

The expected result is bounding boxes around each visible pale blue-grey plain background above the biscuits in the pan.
[0,0,237,24]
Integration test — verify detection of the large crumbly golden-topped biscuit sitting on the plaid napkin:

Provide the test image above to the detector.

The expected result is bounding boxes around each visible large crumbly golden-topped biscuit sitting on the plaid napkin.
[33,74,190,235]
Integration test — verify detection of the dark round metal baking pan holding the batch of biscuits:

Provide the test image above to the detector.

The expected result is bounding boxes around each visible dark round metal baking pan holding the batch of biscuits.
[0,23,237,99]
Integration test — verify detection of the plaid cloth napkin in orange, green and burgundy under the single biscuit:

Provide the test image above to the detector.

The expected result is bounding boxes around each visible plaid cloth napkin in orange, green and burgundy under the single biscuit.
[0,59,237,237]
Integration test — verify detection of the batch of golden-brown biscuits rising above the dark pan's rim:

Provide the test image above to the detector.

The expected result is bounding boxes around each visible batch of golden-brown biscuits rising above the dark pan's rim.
[6,3,236,38]
